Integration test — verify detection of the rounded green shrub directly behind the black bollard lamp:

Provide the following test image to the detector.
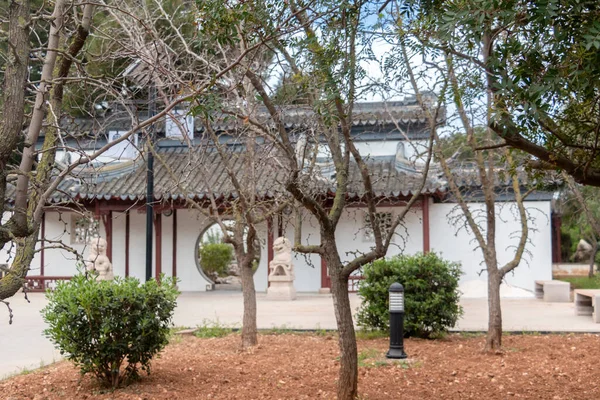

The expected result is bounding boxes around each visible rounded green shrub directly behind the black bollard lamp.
[358,253,462,338]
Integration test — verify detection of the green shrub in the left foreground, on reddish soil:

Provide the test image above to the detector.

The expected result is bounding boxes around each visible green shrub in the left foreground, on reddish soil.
[42,275,179,388]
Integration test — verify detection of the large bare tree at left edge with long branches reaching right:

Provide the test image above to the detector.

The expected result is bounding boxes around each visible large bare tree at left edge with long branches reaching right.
[0,0,260,312]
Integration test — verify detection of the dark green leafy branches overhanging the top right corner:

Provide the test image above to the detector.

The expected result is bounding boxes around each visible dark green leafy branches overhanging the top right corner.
[406,0,600,186]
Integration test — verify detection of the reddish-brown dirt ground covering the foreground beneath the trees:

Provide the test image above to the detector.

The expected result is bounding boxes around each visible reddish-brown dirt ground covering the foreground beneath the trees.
[0,334,600,400]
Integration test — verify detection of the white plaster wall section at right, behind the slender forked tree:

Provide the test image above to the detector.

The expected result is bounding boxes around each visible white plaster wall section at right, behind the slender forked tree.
[429,201,552,290]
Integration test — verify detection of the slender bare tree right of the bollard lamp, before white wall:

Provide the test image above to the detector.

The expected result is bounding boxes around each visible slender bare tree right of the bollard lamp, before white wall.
[396,21,529,351]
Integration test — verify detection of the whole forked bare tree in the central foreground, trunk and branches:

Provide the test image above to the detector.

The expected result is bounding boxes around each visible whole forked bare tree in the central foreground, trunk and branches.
[193,1,441,399]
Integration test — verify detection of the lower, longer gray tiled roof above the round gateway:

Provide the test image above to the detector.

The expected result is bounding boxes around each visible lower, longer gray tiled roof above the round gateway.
[39,147,445,203]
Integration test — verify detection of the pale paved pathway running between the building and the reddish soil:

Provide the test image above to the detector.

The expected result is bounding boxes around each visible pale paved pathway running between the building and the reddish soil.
[0,291,600,378]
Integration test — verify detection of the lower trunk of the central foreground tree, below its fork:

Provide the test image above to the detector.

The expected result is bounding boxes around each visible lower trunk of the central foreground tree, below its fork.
[327,264,358,400]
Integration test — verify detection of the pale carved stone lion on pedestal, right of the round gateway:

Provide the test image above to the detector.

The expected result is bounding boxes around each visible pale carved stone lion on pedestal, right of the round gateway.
[267,237,296,300]
